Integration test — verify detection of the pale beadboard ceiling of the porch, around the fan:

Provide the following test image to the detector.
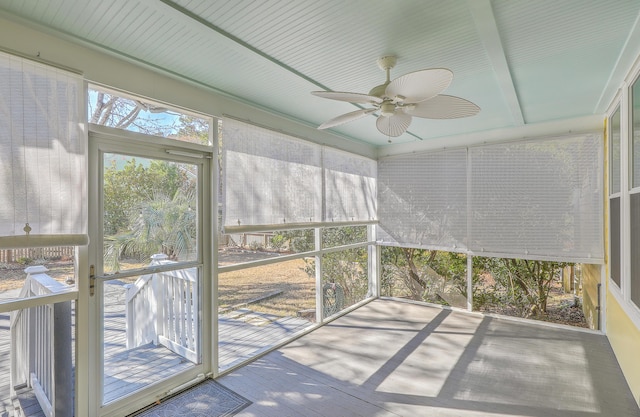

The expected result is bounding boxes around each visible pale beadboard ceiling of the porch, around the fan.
[0,0,640,146]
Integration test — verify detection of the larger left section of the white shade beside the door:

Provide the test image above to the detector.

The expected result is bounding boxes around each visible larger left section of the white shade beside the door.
[222,119,322,233]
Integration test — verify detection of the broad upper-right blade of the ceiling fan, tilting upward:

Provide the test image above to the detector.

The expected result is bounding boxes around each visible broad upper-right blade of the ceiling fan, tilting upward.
[385,68,453,103]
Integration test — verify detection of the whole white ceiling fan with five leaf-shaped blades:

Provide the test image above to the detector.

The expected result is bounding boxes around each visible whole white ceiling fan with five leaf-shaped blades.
[311,56,480,137]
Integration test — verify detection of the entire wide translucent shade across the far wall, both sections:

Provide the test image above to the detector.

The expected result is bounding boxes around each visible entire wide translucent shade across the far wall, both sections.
[378,133,604,263]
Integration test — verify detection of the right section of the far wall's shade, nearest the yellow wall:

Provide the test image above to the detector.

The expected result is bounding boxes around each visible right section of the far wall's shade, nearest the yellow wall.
[469,134,604,262]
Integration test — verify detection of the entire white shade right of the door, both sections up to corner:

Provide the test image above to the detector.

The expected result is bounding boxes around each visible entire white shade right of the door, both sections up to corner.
[222,119,377,233]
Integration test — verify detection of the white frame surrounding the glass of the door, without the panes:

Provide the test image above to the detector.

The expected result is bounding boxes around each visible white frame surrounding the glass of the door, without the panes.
[76,126,214,417]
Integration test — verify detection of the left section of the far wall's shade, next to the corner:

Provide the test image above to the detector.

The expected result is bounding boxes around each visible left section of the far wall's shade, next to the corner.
[378,149,467,251]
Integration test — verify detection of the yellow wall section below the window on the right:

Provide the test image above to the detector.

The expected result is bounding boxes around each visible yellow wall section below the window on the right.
[607,292,640,405]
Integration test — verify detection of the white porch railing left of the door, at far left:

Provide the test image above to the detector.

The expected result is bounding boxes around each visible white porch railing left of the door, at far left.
[10,266,73,417]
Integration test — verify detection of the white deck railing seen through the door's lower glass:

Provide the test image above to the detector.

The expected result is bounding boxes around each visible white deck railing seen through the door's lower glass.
[126,254,200,363]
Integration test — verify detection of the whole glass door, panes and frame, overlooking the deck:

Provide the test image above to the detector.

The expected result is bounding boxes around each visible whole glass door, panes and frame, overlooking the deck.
[91,138,209,415]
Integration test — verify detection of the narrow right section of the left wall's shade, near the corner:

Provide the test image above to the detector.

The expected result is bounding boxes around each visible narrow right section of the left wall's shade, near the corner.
[322,148,378,222]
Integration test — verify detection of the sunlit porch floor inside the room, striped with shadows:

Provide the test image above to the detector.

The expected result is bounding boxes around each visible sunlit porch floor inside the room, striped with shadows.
[218,300,640,417]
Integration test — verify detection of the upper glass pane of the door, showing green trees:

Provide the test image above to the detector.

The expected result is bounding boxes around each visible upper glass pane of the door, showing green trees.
[103,153,198,272]
